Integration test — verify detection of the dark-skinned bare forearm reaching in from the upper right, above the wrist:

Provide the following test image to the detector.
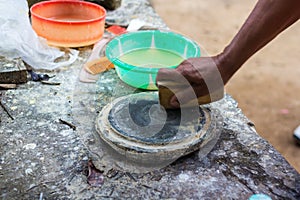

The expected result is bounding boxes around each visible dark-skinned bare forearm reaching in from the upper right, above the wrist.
[214,0,300,83]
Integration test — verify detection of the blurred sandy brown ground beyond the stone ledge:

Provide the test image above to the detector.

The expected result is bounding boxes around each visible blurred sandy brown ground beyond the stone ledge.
[151,0,300,172]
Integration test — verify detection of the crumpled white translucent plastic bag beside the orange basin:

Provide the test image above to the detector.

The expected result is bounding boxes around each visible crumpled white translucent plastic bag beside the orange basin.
[0,0,78,70]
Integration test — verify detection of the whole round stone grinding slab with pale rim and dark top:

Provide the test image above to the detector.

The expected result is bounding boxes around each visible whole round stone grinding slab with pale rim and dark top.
[96,92,217,167]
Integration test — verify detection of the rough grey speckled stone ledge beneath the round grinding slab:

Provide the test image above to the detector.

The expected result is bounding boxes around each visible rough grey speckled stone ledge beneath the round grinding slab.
[0,0,300,199]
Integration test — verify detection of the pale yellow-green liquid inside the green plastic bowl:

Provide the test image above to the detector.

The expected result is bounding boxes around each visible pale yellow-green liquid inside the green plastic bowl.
[119,48,185,68]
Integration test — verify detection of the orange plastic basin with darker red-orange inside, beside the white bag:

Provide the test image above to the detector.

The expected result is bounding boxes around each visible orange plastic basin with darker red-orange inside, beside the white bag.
[30,0,106,47]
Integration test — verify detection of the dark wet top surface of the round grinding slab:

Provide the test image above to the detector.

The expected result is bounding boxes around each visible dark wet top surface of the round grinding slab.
[108,94,206,145]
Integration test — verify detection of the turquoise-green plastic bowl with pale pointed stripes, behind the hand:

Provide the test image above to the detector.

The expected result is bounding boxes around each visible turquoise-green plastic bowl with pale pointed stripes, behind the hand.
[105,30,200,90]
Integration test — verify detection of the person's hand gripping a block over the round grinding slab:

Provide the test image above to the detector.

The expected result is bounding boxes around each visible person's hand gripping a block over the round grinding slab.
[156,57,224,108]
